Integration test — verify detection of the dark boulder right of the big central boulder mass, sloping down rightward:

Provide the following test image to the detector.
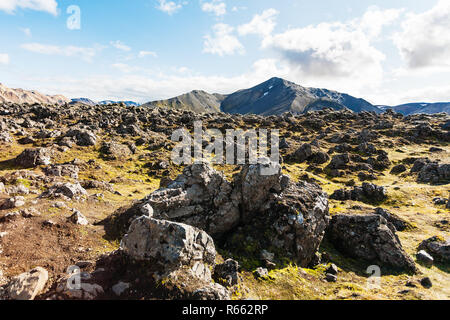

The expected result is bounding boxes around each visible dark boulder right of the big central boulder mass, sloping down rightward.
[328,214,416,272]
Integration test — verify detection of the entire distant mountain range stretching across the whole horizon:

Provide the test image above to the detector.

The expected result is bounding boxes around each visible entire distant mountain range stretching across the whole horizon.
[0,78,450,116]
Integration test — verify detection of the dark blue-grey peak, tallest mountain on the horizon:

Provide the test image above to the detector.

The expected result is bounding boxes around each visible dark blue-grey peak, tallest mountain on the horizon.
[221,78,380,115]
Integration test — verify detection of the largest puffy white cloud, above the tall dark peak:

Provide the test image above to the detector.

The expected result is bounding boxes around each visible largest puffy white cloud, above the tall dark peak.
[258,7,401,92]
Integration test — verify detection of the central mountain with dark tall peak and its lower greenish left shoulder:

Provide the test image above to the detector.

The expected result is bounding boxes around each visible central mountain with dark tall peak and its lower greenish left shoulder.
[143,78,381,115]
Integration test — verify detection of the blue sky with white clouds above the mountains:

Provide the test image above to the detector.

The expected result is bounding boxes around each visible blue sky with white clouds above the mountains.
[0,0,450,105]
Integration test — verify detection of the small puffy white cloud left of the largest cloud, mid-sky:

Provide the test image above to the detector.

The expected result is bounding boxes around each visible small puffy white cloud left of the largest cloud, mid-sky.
[203,23,245,56]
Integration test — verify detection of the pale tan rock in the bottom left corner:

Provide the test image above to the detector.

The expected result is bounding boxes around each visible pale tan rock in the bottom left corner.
[7,267,48,300]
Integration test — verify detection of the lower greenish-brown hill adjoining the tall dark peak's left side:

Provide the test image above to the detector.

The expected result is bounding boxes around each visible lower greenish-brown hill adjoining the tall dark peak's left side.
[142,90,226,113]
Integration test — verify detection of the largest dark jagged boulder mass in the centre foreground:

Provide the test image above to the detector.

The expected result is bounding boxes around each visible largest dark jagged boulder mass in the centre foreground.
[144,161,329,266]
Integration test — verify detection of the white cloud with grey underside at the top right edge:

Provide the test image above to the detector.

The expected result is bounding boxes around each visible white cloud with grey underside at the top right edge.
[394,0,450,69]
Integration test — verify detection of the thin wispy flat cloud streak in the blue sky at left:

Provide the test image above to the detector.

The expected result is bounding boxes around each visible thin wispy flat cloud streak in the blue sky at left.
[21,43,103,61]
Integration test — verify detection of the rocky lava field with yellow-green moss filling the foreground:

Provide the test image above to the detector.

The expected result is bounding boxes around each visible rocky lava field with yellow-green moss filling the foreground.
[0,104,450,299]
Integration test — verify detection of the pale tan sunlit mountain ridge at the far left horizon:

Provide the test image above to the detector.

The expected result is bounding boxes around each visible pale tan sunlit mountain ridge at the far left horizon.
[0,83,70,105]
